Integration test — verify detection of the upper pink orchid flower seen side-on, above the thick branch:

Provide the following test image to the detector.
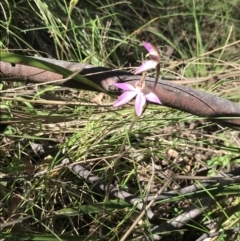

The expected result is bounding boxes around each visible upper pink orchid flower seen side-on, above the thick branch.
[135,42,160,74]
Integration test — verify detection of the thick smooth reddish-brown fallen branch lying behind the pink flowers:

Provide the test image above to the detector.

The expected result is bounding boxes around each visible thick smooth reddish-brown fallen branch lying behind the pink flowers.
[0,58,240,129]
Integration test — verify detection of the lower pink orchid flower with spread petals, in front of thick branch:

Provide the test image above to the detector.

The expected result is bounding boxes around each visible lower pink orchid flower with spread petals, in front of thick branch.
[113,81,162,116]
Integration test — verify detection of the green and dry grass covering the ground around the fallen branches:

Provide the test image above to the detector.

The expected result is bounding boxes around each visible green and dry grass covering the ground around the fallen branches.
[0,0,240,241]
